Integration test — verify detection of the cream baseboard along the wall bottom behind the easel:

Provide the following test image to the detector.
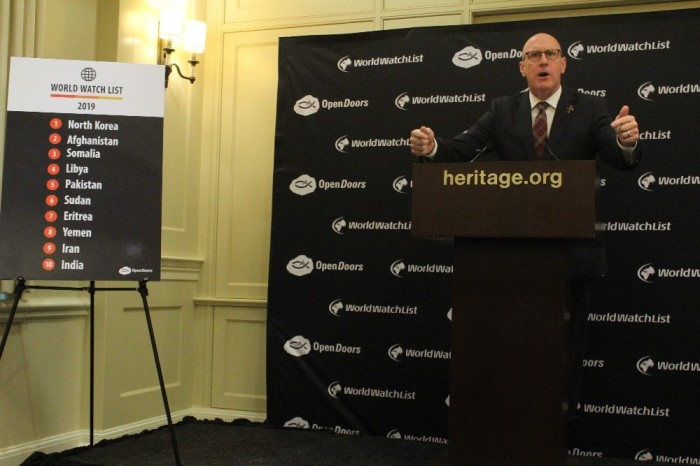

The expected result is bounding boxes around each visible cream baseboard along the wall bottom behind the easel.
[0,408,266,466]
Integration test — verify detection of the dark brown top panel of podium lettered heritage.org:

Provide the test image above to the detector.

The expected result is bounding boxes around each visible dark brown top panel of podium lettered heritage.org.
[411,160,595,238]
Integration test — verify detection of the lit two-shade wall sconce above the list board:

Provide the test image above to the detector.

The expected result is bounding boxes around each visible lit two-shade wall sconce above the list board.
[158,6,207,88]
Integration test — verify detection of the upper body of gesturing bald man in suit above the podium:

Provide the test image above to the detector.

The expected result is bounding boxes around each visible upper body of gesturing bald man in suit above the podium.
[410,33,640,170]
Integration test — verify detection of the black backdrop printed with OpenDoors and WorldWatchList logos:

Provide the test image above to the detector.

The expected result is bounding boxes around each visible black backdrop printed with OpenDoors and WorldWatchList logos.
[267,10,700,464]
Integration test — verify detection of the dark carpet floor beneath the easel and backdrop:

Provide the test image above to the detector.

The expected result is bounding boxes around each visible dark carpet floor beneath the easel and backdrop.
[22,418,661,466]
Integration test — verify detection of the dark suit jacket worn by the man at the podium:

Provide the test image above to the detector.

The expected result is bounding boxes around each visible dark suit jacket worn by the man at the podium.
[433,87,641,170]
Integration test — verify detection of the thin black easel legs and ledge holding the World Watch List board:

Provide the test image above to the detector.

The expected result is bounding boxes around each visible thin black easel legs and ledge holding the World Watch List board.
[0,277,181,466]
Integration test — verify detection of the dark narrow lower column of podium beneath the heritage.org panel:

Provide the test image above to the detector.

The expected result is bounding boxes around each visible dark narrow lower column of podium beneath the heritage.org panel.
[448,239,569,466]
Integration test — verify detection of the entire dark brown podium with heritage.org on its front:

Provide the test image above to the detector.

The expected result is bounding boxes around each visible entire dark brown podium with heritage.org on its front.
[412,160,595,466]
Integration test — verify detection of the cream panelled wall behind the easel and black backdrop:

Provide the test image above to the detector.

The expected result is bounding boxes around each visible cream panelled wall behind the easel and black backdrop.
[0,0,700,465]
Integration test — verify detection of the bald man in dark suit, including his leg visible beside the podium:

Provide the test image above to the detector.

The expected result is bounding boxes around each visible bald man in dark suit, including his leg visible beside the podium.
[410,33,641,434]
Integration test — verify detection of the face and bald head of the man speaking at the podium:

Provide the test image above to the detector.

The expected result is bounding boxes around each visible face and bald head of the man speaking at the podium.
[520,34,566,100]
